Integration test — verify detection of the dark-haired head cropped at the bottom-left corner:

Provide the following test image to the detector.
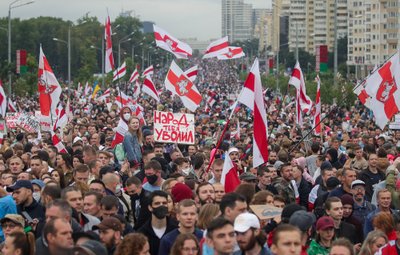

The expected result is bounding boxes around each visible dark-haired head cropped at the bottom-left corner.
[1,232,35,255]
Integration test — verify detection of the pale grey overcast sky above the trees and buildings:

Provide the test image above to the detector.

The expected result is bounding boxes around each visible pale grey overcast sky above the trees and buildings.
[0,0,271,40]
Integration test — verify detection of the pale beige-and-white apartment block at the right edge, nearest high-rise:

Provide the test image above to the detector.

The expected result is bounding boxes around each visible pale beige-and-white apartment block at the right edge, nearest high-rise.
[347,0,400,77]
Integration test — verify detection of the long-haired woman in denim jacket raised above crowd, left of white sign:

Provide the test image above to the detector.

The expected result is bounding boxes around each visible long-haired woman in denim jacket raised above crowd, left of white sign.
[122,116,142,163]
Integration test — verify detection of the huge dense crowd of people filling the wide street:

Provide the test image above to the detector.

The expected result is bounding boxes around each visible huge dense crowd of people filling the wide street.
[0,57,400,255]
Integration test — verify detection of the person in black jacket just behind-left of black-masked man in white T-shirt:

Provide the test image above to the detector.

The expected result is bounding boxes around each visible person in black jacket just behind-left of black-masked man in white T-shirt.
[125,176,151,230]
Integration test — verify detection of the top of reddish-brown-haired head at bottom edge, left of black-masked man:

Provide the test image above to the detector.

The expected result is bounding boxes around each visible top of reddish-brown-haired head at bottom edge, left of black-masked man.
[114,233,150,255]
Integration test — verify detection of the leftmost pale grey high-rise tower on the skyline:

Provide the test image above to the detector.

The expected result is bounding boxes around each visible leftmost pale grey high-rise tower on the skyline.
[221,0,253,42]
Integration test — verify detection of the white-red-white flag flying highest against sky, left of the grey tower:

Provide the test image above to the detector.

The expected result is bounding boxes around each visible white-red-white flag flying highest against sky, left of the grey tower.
[153,25,192,59]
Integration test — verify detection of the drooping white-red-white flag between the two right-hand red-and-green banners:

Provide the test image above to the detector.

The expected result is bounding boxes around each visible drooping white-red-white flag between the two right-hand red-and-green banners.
[289,61,312,113]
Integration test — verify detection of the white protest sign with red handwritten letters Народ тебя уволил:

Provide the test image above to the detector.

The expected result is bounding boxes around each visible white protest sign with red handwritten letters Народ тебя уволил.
[154,111,195,144]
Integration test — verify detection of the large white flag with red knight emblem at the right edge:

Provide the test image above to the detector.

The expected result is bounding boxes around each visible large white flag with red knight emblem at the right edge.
[358,52,400,129]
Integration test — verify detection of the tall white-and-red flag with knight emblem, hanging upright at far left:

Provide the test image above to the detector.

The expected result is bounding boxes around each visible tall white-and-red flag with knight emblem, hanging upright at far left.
[38,46,62,130]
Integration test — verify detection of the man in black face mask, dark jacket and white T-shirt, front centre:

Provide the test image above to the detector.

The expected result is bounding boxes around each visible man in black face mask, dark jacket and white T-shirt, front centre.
[138,190,178,254]
